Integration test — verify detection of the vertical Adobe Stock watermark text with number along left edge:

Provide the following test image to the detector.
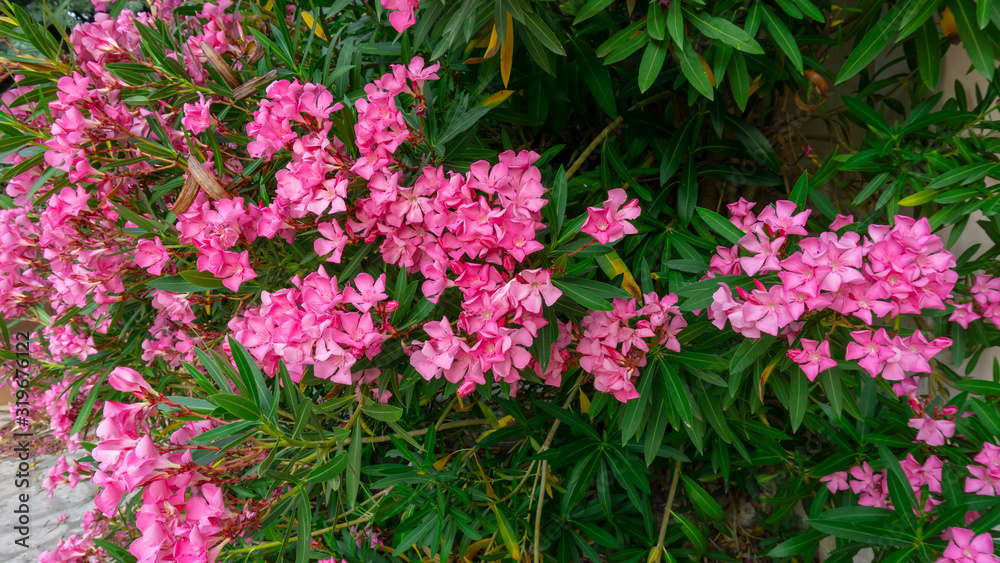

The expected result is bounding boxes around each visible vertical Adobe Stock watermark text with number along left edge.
[10,332,34,549]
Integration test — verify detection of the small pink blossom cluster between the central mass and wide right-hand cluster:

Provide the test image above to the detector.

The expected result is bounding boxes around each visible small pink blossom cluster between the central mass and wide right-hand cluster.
[576,293,687,403]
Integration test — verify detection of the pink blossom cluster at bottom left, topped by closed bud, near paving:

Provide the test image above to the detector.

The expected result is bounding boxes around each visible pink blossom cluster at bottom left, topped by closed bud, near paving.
[91,367,252,563]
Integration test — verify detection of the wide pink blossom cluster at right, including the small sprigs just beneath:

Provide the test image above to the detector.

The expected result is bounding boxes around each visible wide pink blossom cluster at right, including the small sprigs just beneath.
[708,199,958,381]
